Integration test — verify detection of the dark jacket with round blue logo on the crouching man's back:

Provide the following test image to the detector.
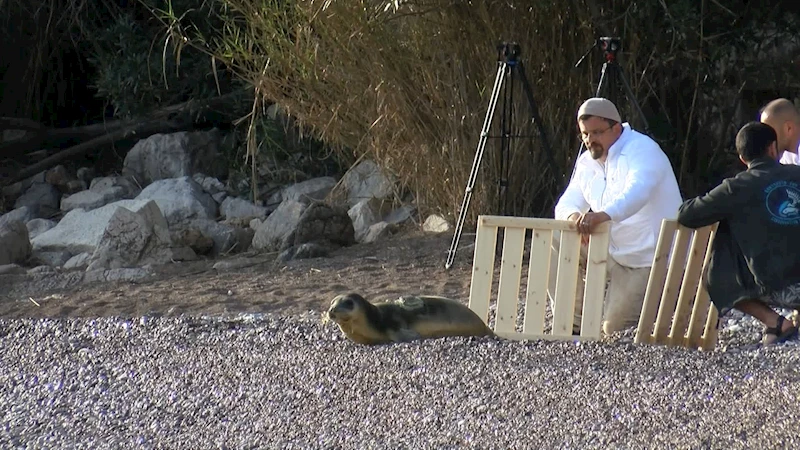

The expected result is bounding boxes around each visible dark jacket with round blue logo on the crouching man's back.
[678,158,800,315]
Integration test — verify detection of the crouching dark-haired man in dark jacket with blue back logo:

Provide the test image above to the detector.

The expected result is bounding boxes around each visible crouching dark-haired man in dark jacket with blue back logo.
[678,122,800,344]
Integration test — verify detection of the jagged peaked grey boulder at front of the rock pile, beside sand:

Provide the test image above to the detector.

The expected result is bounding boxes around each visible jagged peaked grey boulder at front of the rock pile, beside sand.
[86,201,196,271]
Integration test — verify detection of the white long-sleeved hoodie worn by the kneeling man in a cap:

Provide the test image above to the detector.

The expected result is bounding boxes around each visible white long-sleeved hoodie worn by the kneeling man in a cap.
[555,123,683,267]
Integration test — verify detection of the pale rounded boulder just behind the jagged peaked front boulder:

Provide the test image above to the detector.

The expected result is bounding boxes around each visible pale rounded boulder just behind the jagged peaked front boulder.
[136,176,219,227]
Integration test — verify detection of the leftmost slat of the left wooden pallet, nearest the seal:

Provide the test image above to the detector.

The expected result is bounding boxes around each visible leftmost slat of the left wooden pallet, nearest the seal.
[469,218,497,323]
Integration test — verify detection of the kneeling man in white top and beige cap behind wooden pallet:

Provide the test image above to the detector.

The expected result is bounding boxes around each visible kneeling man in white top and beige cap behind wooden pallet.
[551,98,683,334]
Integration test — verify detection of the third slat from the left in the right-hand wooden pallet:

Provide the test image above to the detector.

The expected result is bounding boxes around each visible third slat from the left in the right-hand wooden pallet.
[668,227,711,345]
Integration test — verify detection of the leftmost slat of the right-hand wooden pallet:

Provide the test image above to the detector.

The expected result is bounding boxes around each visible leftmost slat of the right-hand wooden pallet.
[634,220,678,344]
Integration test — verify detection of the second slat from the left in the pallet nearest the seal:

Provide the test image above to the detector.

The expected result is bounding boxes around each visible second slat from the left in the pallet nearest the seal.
[495,228,525,331]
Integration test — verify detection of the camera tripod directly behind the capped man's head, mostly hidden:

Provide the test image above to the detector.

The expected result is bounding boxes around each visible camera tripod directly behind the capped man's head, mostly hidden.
[562,37,651,183]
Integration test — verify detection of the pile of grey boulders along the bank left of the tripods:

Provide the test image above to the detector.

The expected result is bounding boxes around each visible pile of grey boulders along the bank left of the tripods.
[0,129,450,278]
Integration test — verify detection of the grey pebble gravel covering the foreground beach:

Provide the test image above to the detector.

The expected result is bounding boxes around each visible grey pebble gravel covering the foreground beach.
[0,313,800,449]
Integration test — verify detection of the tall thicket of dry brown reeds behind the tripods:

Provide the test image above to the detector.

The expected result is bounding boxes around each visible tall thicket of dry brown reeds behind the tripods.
[7,0,799,229]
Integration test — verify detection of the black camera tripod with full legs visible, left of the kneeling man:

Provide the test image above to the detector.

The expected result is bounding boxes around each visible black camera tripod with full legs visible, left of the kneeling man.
[445,42,562,269]
